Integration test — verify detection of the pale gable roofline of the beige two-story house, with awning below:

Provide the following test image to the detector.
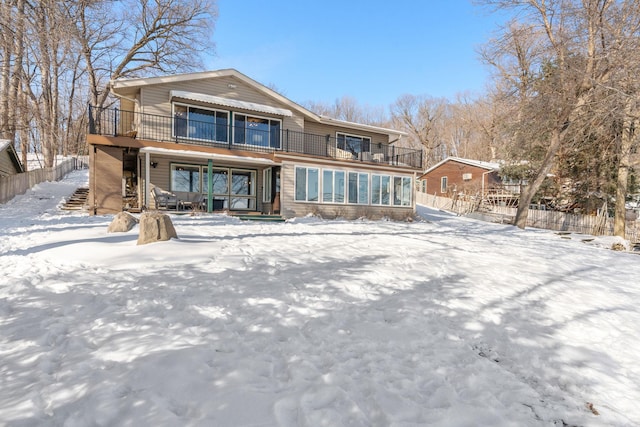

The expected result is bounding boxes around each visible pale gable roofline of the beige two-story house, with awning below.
[109,68,408,137]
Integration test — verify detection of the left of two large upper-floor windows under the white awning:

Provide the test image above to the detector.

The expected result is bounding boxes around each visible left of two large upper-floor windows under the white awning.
[173,104,229,142]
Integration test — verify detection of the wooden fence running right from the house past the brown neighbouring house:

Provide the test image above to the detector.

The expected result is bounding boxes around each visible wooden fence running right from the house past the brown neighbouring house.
[416,192,640,243]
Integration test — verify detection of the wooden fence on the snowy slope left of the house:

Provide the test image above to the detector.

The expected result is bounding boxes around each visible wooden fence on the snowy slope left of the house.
[0,158,87,203]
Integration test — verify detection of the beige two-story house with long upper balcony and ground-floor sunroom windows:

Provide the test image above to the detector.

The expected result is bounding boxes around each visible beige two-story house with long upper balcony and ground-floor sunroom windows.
[87,69,422,219]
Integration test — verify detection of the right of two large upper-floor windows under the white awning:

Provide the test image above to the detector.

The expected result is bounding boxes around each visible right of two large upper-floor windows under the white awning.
[233,114,281,149]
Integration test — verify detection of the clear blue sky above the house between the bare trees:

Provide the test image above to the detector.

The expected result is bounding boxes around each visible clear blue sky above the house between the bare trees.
[206,0,499,108]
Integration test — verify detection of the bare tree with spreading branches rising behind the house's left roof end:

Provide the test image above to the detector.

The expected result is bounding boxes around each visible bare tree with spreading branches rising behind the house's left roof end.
[68,0,217,112]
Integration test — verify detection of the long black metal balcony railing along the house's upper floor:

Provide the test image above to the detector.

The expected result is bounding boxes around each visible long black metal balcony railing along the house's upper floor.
[89,107,422,168]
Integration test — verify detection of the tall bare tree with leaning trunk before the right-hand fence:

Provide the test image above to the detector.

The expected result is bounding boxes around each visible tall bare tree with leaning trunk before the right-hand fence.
[482,0,637,228]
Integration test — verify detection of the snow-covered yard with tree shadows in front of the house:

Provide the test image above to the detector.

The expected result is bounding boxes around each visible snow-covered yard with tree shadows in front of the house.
[0,171,640,427]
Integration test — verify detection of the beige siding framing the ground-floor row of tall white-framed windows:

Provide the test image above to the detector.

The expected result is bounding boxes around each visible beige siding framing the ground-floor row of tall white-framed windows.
[280,162,415,220]
